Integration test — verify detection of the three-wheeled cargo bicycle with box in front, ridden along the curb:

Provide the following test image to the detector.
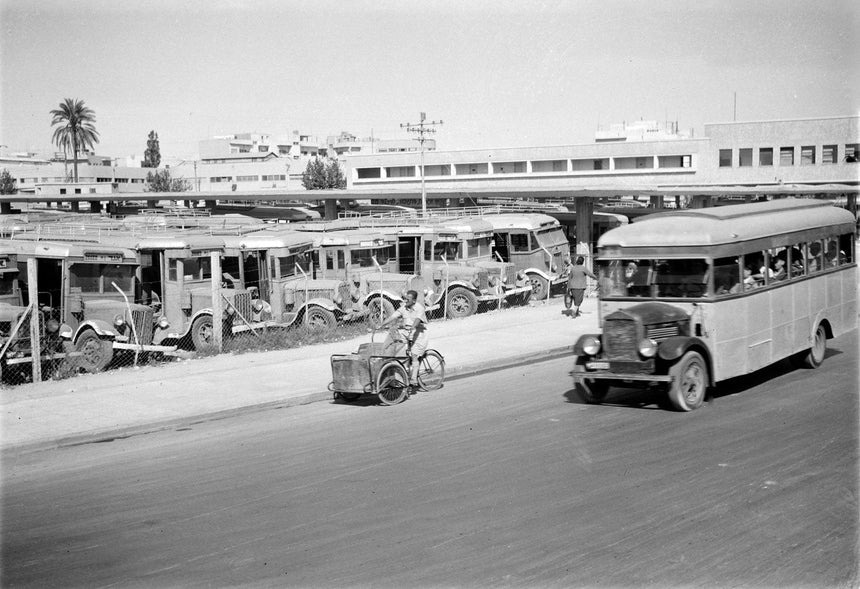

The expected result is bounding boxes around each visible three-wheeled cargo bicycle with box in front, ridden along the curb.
[328,342,445,405]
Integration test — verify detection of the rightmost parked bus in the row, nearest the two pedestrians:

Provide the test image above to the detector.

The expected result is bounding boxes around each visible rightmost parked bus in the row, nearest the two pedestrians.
[482,213,570,300]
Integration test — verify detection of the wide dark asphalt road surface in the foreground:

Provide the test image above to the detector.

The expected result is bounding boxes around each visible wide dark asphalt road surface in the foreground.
[2,332,858,588]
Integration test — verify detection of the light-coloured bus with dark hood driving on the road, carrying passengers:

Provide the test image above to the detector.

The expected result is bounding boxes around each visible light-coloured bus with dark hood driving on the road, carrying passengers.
[573,199,857,411]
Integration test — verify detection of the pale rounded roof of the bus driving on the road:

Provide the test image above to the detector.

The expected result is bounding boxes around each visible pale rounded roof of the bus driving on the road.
[597,199,854,247]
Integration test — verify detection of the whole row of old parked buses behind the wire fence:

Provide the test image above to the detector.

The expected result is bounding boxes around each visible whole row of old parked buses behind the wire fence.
[0,214,569,372]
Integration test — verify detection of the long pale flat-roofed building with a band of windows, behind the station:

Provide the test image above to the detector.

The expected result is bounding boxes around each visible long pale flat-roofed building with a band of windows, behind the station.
[346,116,860,193]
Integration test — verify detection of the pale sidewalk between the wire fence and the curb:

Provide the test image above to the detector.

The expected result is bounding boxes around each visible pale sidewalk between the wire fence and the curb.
[0,297,597,452]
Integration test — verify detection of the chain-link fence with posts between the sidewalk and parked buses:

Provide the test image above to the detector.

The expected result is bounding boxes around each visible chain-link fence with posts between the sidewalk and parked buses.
[0,254,564,387]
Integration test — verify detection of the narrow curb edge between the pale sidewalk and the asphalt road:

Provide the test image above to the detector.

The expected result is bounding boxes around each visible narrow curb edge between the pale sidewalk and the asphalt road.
[2,345,573,454]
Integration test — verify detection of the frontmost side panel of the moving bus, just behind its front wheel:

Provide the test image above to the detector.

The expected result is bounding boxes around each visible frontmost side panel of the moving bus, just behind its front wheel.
[705,299,747,381]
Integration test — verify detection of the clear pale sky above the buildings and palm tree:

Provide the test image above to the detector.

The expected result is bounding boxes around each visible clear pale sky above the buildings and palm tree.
[0,0,860,159]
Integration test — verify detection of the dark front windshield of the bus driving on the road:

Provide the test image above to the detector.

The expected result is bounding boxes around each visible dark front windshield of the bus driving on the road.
[598,258,711,298]
